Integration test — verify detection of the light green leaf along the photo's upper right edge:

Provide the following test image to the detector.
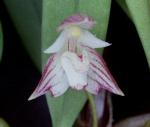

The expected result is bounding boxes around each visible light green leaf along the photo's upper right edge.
[118,0,150,66]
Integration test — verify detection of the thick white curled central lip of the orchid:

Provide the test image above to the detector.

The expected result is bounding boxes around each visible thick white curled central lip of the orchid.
[61,52,88,90]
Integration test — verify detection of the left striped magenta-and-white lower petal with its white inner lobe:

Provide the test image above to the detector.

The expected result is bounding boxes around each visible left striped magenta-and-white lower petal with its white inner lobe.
[28,54,68,100]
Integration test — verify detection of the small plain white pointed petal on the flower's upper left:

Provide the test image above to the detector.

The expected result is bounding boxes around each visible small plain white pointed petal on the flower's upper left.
[44,31,66,53]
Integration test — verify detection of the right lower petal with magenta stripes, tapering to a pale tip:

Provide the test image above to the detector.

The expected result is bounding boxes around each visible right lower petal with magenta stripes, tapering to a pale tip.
[86,47,124,96]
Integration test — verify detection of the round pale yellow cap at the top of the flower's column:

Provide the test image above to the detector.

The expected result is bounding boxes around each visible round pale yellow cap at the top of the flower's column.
[70,26,81,37]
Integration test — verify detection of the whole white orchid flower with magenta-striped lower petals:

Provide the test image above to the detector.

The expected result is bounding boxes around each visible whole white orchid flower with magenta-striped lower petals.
[29,14,123,100]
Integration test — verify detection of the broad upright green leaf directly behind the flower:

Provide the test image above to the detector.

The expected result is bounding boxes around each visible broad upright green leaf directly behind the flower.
[42,0,111,127]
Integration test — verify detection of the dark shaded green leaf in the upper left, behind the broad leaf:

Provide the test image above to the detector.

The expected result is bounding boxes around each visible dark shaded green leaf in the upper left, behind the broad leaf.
[4,0,42,69]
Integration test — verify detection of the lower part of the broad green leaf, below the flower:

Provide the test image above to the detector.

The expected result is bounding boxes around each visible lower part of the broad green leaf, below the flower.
[47,89,87,127]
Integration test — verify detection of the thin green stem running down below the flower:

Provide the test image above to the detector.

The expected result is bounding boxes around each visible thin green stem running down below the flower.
[87,92,98,127]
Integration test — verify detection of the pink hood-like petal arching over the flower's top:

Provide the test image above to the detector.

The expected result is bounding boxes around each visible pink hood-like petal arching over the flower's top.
[57,14,96,31]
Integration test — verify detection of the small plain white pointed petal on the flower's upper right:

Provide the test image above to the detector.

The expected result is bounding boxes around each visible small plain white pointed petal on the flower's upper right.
[78,30,110,48]
